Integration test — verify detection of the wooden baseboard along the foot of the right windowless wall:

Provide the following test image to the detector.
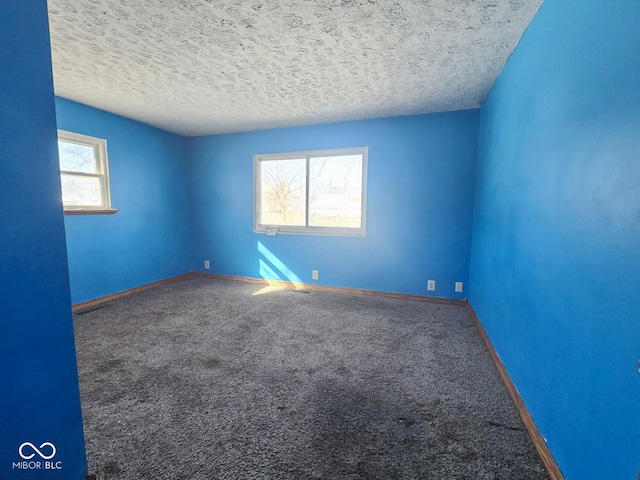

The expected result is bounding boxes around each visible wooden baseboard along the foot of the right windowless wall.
[467,303,564,480]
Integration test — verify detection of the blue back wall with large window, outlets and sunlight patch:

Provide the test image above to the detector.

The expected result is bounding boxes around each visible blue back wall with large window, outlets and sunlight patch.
[189,110,478,298]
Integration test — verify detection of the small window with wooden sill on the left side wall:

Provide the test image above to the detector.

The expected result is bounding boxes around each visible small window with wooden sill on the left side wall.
[58,130,111,211]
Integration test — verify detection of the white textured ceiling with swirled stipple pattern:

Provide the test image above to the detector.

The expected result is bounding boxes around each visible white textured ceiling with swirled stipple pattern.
[49,0,542,136]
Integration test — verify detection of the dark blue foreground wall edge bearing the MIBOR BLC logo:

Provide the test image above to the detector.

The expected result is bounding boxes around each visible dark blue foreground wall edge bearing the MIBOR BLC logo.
[0,0,87,480]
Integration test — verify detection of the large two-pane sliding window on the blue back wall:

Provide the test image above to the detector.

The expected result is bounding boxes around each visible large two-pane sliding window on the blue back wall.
[253,147,368,236]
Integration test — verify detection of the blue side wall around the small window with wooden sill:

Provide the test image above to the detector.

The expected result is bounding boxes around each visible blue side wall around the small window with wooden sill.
[56,98,190,303]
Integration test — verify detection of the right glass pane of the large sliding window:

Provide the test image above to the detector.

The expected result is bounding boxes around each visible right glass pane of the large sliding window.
[309,155,362,228]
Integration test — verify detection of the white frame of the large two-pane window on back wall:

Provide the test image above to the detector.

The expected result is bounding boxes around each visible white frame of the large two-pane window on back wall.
[253,147,369,237]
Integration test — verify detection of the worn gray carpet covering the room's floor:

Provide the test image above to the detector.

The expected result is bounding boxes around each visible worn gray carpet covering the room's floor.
[75,278,548,480]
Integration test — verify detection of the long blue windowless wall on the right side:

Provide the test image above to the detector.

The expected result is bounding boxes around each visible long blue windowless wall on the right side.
[470,0,640,480]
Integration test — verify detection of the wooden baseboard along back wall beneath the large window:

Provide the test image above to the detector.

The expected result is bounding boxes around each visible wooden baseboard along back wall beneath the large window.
[194,273,467,306]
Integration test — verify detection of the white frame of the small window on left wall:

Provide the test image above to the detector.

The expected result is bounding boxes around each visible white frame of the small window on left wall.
[58,129,111,212]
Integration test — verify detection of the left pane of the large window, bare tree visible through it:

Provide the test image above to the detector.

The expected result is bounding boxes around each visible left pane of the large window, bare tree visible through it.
[260,158,306,226]
